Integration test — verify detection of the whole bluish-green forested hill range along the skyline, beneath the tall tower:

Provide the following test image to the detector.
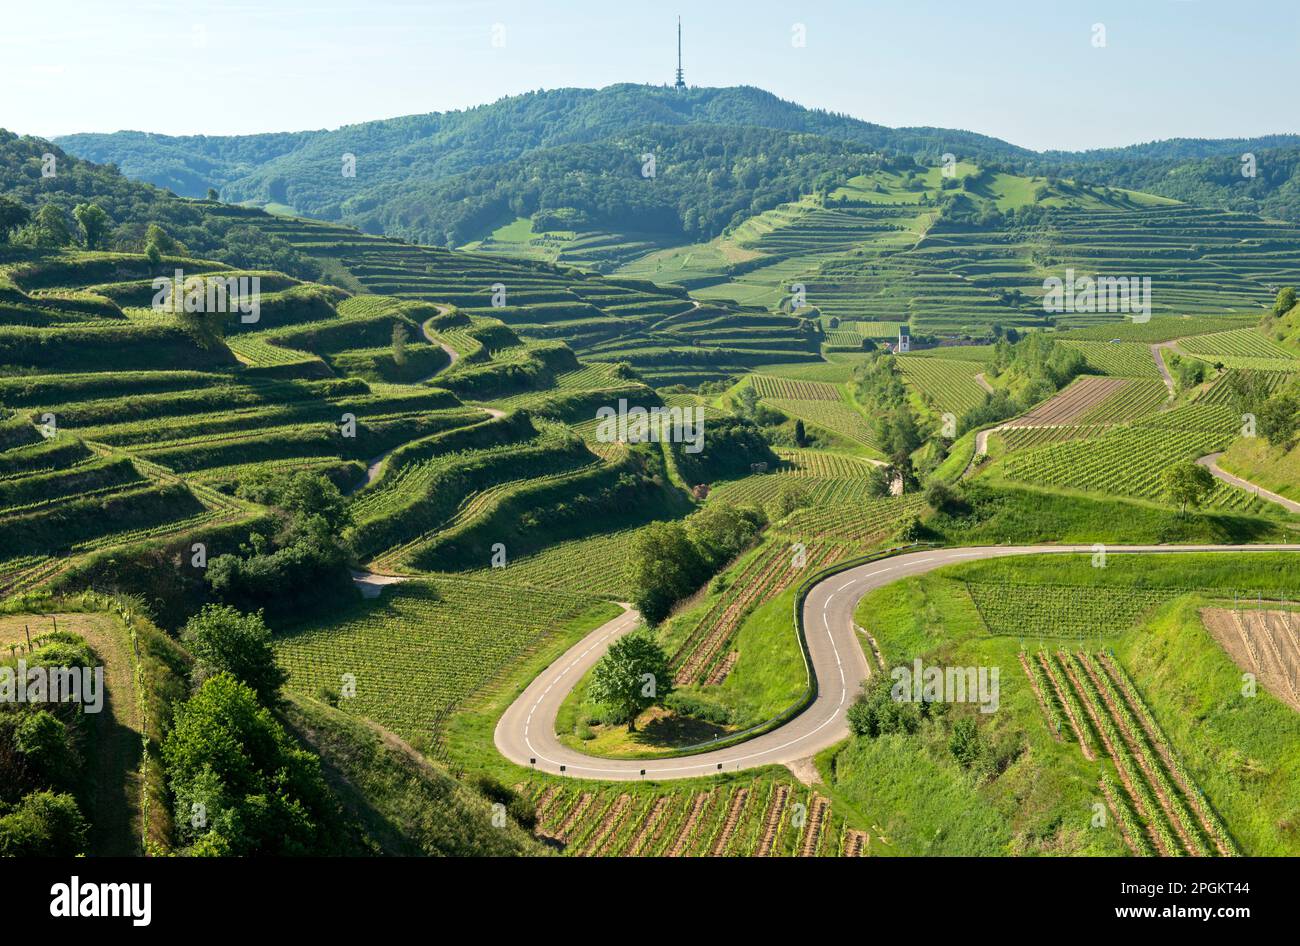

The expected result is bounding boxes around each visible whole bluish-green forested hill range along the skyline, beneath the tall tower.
[50,84,1300,246]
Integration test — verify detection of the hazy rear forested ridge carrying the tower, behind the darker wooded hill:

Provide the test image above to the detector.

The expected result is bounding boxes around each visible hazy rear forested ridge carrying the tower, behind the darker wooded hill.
[56,84,1028,200]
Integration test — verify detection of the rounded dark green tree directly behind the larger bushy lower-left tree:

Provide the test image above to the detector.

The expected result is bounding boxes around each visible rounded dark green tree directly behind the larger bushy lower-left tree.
[181,604,287,706]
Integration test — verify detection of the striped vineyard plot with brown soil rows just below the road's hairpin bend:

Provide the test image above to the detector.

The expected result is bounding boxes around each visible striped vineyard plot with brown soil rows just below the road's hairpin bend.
[520,778,871,858]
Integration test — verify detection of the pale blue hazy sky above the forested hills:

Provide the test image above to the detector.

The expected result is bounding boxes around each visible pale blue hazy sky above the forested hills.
[0,0,1300,151]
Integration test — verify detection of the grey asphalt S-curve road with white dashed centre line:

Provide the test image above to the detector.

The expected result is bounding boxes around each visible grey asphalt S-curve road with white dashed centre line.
[495,544,1300,781]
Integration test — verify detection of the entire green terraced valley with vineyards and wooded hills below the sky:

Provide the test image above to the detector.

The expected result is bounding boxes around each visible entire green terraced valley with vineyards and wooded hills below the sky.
[0,77,1300,858]
